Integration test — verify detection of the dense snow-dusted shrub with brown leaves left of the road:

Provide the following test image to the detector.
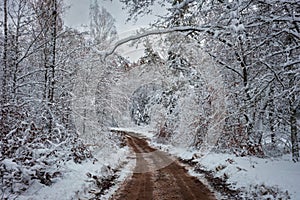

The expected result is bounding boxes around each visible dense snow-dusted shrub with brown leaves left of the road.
[0,121,92,196]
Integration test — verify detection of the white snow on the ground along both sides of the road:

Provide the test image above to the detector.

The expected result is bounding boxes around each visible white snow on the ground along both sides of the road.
[17,127,300,200]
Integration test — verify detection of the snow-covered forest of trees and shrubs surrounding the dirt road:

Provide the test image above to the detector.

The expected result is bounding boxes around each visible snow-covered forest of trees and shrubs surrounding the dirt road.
[0,0,300,199]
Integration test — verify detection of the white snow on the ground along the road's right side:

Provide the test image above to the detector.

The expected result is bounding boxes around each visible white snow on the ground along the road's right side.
[123,128,300,200]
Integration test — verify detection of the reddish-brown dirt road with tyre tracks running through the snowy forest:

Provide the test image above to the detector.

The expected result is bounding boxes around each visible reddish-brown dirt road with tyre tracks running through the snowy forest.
[111,133,215,200]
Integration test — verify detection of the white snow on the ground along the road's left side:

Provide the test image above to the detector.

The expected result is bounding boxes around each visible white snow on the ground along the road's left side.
[17,147,134,200]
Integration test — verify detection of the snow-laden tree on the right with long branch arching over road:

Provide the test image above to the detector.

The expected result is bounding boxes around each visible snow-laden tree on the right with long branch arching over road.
[113,0,299,157]
